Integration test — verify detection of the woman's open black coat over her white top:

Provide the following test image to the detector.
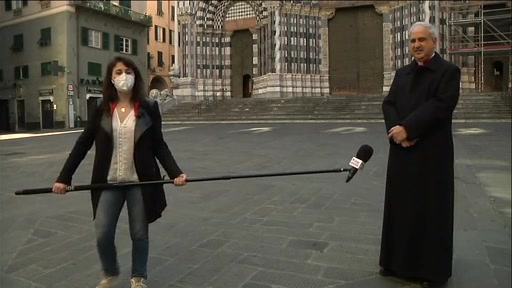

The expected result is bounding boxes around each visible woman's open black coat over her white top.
[57,99,182,223]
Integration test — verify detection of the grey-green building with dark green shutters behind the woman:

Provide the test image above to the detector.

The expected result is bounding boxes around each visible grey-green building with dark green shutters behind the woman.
[0,1,152,131]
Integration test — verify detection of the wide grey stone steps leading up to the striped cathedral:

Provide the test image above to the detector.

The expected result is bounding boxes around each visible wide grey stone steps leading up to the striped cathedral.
[163,95,511,121]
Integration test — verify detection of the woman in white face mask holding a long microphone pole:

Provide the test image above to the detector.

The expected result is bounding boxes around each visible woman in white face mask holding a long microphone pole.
[53,57,187,288]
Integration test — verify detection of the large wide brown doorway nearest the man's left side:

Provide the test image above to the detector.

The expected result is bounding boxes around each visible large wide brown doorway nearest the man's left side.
[328,5,384,94]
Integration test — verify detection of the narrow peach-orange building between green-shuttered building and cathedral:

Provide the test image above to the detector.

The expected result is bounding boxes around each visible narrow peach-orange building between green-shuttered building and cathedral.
[146,0,180,91]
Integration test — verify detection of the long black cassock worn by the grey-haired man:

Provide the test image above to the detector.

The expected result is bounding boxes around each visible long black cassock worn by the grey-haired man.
[380,53,460,281]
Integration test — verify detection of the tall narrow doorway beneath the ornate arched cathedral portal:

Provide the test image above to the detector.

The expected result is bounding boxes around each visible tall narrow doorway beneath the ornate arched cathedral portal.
[231,29,253,98]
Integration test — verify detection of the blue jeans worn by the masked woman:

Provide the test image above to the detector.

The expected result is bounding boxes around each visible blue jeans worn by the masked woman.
[94,186,149,278]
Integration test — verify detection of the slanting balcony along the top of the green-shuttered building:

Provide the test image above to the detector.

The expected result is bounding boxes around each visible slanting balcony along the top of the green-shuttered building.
[70,0,153,27]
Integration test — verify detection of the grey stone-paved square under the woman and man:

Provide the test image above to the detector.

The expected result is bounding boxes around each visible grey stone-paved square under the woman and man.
[0,123,511,288]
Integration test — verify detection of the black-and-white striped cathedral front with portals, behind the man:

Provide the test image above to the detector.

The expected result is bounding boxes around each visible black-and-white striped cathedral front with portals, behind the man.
[174,0,512,101]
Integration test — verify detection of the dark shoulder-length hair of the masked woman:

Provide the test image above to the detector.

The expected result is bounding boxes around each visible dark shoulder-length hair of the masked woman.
[101,56,147,111]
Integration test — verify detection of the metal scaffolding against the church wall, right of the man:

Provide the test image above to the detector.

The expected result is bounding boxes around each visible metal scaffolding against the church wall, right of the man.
[442,1,512,92]
